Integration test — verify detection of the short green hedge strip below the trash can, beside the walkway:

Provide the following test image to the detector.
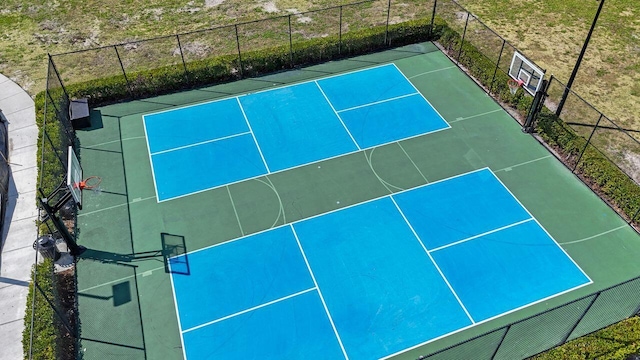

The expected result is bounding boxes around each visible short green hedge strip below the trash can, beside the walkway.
[22,259,56,360]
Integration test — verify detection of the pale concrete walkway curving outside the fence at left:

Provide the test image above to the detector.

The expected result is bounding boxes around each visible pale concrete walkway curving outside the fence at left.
[0,75,38,360]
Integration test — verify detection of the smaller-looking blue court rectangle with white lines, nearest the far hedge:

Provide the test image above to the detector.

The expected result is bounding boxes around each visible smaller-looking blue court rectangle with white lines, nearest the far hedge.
[143,64,449,201]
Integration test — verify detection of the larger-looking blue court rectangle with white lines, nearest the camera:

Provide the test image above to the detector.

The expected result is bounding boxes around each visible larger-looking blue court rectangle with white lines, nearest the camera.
[170,169,591,360]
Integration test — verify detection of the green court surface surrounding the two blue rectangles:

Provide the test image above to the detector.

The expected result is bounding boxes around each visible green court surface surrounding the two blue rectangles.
[77,43,640,359]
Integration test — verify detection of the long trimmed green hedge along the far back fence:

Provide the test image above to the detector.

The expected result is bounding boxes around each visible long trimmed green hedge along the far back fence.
[66,19,436,106]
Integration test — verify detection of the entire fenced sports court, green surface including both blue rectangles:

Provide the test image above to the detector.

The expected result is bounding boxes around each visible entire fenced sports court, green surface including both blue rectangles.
[77,43,640,360]
